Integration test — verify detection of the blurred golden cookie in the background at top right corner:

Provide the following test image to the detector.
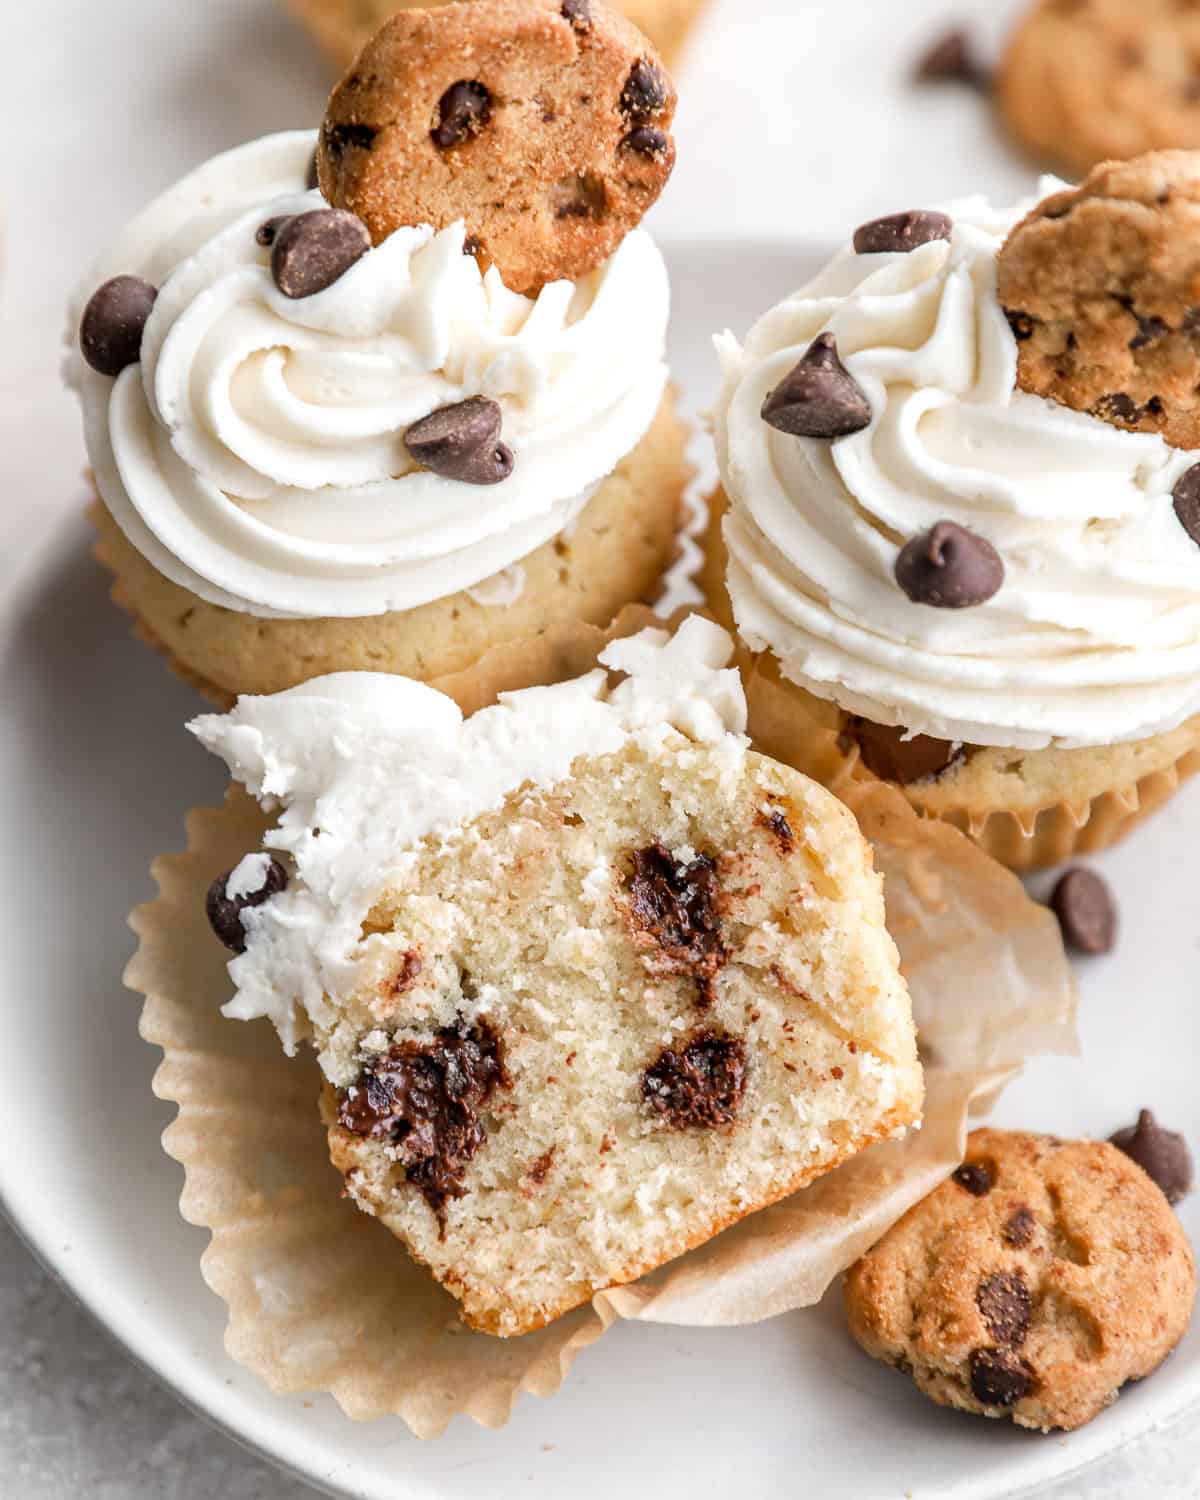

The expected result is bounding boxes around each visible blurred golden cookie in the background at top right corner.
[996,0,1200,177]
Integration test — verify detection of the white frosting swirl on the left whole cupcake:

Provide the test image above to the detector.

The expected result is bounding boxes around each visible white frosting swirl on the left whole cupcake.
[69,131,669,617]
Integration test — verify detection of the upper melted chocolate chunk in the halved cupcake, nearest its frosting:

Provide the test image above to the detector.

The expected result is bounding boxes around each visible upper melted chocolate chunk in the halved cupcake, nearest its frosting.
[627,845,726,1005]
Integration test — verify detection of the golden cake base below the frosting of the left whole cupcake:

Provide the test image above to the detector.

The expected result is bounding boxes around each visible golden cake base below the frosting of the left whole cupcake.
[93,396,689,707]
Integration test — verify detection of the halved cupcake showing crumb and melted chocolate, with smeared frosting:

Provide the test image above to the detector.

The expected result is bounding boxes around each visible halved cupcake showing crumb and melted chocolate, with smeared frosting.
[192,617,923,1337]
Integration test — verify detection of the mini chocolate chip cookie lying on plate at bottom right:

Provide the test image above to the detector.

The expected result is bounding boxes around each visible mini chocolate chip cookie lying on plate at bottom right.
[846,1130,1196,1431]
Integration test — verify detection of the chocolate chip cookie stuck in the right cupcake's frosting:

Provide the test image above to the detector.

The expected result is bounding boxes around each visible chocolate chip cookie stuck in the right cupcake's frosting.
[998,152,1200,449]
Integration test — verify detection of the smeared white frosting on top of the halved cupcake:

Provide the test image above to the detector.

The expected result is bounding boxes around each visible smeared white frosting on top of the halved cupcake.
[189,615,747,1082]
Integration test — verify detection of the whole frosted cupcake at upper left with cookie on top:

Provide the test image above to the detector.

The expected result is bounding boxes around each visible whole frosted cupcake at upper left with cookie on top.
[69,0,687,705]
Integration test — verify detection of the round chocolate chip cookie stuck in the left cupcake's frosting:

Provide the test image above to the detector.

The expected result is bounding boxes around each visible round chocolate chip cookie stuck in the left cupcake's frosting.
[318,0,675,296]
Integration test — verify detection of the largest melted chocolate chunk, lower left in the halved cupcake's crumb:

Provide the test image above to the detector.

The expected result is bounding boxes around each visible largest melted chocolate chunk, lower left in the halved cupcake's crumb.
[338,1017,509,1230]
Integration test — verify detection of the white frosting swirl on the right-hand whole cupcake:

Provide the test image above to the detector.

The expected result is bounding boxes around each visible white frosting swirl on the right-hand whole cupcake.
[717,185,1200,749]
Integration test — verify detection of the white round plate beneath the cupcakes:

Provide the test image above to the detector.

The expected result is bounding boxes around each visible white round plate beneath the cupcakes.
[0,243,1200,1500]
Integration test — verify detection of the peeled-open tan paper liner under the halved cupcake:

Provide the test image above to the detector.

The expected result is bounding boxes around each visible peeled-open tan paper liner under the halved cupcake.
[126,639,1076,1437]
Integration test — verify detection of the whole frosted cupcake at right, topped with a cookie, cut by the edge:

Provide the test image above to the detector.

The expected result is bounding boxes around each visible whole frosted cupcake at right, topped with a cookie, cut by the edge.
[708,172,1200,869]
